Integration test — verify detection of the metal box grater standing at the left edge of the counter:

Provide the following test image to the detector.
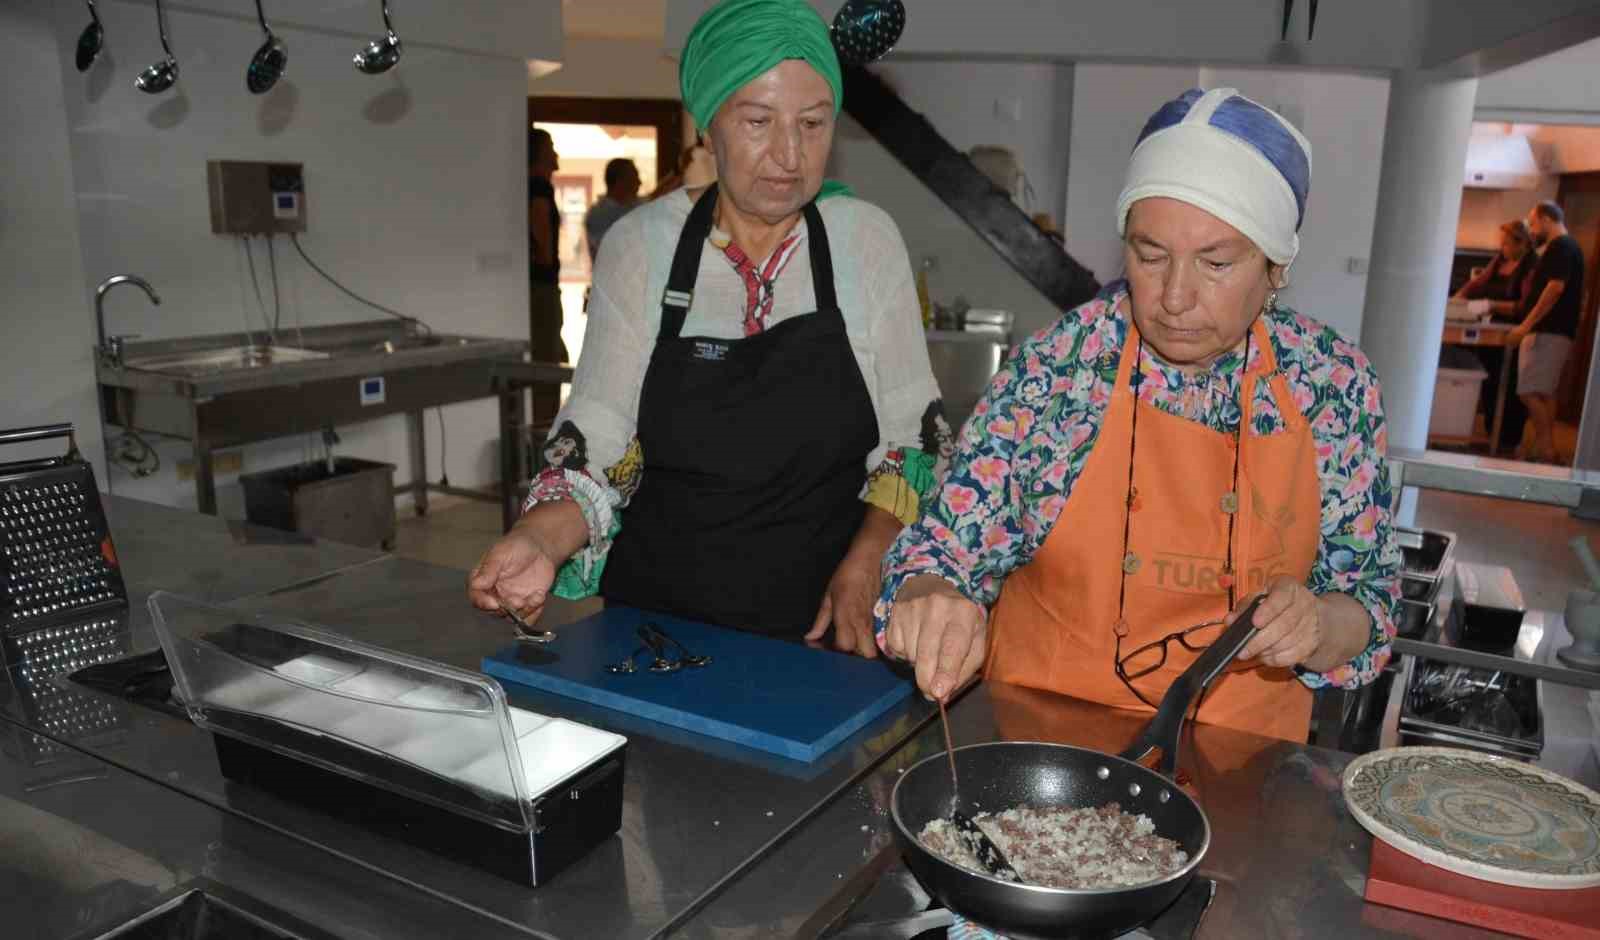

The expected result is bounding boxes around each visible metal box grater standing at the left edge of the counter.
[0,424,128,636]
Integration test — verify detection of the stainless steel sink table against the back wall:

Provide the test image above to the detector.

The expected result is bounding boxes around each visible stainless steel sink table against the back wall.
[96,320,528,515]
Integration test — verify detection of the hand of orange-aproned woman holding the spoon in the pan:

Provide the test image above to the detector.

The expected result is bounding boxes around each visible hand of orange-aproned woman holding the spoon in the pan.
[883,574,989,702]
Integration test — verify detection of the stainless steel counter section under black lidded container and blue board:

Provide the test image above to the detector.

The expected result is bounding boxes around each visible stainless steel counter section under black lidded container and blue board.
[0,497,933,938]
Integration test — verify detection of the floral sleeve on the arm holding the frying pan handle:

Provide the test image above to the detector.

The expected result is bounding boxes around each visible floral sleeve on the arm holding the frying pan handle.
[1301,337,1400,689]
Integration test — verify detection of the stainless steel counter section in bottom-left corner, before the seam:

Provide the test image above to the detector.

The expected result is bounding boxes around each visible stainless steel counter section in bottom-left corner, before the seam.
[0,723,542,940]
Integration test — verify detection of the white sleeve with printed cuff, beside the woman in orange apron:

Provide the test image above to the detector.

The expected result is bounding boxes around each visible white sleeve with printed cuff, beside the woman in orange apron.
[851,203,955,526]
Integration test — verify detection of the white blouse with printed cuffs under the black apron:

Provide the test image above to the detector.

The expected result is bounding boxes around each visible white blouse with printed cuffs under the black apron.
[528,189,949,590]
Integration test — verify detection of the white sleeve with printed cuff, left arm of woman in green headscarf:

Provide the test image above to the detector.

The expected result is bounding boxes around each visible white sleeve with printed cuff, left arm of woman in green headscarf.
[523,219,651,599]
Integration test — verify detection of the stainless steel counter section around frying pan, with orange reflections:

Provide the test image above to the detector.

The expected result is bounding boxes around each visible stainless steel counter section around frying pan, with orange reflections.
[669,684,1502,940]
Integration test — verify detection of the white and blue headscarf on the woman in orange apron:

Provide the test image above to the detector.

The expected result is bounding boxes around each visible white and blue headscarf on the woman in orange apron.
[1117,88,1310,265]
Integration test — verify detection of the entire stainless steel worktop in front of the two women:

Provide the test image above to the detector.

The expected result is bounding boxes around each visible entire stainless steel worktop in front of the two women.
[0,497,1523,940]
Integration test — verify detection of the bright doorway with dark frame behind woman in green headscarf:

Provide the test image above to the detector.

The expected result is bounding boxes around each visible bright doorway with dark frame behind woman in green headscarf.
[528,98,683,363]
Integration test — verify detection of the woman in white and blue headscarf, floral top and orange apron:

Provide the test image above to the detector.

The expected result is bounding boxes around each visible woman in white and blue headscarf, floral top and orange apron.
[875,88,1400,740]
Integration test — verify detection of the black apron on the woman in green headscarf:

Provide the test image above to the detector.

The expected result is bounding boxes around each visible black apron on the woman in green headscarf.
[600,187,878,636]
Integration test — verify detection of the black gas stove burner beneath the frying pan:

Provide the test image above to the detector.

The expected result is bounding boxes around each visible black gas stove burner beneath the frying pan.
[821,847,1216,940]
